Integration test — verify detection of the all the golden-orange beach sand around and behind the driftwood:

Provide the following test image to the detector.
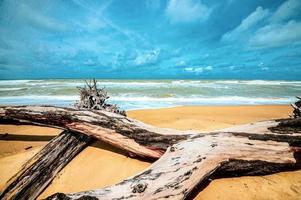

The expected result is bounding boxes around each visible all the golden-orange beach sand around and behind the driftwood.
[0,105,301,200]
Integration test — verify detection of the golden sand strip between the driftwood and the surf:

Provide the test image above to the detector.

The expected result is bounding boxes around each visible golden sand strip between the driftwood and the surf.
[128,105,291,131]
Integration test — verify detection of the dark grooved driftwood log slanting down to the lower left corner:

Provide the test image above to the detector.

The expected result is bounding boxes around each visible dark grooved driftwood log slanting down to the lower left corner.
[0,131,92,200]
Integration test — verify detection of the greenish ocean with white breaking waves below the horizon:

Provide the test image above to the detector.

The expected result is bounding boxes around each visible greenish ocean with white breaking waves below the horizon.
[0,79,301,110]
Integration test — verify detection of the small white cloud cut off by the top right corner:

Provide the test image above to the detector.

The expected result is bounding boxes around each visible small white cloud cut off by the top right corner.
[271,0,301,22]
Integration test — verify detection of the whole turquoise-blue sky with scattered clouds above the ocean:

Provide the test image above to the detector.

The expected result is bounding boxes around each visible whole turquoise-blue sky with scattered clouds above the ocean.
[0,0,301,80]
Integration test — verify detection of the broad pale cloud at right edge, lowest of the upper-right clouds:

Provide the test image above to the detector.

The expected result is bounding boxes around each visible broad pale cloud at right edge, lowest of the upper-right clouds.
[250,20,301,48]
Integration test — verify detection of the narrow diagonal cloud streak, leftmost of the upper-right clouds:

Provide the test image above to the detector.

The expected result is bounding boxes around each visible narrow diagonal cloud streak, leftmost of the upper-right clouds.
[222,6,269,41]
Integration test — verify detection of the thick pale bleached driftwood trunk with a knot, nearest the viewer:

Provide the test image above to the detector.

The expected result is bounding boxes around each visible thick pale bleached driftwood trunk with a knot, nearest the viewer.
[48,132,301,200]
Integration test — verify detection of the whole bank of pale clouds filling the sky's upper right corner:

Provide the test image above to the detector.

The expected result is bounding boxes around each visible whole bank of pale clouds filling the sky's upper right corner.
[221,0,301,48]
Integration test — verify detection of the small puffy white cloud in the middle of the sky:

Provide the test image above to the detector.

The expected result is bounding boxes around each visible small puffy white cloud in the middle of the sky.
[134,49,160,66]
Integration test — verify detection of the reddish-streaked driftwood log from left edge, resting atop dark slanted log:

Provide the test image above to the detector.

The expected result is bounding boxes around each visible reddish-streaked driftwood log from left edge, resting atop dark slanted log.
[0,106,192,159]
